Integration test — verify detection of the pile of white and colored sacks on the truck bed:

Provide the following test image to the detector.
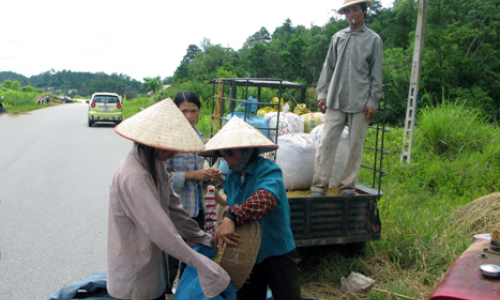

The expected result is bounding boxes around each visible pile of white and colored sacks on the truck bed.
[219,97,349,190]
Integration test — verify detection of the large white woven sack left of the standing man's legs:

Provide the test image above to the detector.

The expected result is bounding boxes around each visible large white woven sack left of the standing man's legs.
[276,133,316,190]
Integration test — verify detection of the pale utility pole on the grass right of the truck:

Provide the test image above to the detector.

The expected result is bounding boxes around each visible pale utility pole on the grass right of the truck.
[401,0,429,163]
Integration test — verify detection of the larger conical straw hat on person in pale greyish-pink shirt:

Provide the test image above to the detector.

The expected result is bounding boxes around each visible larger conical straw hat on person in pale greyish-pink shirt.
[115,98,204,152]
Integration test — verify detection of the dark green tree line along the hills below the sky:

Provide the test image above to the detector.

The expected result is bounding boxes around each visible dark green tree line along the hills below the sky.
[0,0,500,125]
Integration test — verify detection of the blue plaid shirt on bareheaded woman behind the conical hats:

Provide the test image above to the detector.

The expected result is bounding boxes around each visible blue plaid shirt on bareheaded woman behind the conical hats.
[165,127,205,218]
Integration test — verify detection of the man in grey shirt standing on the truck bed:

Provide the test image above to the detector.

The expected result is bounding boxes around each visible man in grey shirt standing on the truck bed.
[311,0,383,196]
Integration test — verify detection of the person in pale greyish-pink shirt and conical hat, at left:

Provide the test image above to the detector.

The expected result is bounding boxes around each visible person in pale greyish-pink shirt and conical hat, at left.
[107,98,230,300]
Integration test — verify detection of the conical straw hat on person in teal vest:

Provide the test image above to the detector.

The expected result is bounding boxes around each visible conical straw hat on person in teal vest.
[198,116,278,156]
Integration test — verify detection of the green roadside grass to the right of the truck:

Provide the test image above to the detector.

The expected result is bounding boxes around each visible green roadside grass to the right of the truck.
[303,103,500,299]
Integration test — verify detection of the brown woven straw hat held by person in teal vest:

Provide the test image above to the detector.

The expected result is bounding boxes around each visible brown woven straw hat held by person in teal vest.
[214,221,262,289]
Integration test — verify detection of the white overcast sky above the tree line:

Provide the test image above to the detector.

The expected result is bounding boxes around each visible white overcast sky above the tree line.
[0,0,393,81]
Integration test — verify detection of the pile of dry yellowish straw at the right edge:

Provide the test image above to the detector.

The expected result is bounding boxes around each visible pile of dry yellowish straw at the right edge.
[451,193,500,235]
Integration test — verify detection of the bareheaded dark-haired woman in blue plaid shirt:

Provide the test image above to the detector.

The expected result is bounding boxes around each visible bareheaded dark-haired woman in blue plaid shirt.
[165,91,221,294]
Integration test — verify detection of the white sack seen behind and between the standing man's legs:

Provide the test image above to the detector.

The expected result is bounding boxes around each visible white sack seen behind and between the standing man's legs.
[311,124,349,187]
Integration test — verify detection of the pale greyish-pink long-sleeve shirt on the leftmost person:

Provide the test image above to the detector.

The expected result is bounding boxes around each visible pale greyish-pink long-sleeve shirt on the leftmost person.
[107,144,229,299]
